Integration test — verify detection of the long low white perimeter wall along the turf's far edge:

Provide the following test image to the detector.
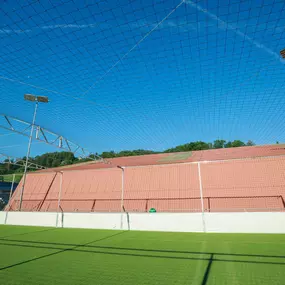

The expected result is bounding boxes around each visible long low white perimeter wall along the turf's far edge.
[0,212,285,233]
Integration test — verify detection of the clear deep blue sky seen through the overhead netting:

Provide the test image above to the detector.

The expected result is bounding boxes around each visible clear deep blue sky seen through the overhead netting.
[0,0,285,156]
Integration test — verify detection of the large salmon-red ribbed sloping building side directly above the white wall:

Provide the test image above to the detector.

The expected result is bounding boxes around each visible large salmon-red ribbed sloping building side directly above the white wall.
[3,156,285,212]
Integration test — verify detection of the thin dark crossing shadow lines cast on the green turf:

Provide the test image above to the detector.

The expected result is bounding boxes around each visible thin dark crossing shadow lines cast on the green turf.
[0,232,285,285]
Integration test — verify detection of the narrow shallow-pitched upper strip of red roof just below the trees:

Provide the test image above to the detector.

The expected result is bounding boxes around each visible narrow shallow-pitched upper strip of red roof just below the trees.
[38,144,285,172]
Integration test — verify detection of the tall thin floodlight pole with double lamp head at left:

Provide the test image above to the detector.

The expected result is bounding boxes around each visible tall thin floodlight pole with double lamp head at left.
[19,94,48,211]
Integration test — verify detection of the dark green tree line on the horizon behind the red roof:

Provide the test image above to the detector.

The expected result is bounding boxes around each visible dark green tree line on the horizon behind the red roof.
[0,139,255,175]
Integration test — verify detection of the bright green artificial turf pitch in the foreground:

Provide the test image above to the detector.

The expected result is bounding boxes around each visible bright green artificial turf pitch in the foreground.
[0,226,285,285]
